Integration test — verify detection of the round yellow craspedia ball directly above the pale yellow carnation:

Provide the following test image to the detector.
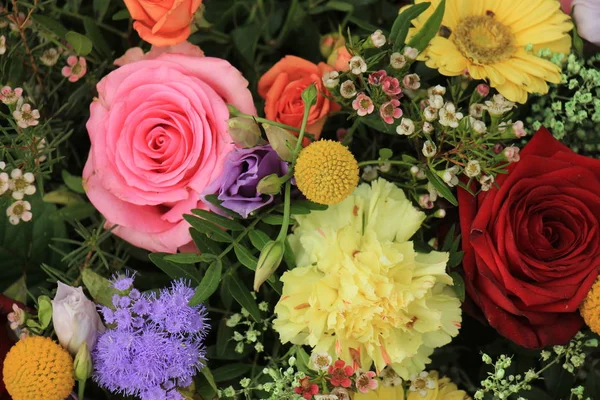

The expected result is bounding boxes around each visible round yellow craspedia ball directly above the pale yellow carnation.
[294,140,358,205]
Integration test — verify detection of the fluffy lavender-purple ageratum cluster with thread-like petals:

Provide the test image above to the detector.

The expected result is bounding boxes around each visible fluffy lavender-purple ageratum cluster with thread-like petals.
[92,280,209,400]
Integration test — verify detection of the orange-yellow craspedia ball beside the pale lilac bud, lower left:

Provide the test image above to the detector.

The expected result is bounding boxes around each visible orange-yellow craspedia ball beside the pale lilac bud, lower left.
[2,336,75,400]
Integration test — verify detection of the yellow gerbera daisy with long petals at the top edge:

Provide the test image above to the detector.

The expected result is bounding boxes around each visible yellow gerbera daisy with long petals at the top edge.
[412,0,573,103]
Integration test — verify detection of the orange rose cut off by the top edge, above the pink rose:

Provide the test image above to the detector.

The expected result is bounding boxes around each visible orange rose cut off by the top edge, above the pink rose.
[125,0,202,46]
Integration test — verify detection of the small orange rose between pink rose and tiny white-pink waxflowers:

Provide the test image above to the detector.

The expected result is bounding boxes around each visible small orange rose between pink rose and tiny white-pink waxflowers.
[258,56,340,139]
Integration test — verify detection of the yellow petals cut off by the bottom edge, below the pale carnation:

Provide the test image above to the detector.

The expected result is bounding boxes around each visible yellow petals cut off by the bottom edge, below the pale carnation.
[352,371,471,400]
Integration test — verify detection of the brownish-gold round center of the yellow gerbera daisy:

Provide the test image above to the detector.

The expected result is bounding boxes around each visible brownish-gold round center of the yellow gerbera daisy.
[452,15,515,65]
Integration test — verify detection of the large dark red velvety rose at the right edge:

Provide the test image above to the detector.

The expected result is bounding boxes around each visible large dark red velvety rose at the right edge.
[459,128,600,348]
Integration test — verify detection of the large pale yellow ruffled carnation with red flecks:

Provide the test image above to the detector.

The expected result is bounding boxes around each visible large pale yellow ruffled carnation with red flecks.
[274,179,461,379]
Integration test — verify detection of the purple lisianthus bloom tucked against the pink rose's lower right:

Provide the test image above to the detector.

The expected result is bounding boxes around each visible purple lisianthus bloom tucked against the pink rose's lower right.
[204,145,287,218]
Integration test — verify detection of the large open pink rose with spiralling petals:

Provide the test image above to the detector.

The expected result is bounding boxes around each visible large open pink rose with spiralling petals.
[83,52,256,253]
